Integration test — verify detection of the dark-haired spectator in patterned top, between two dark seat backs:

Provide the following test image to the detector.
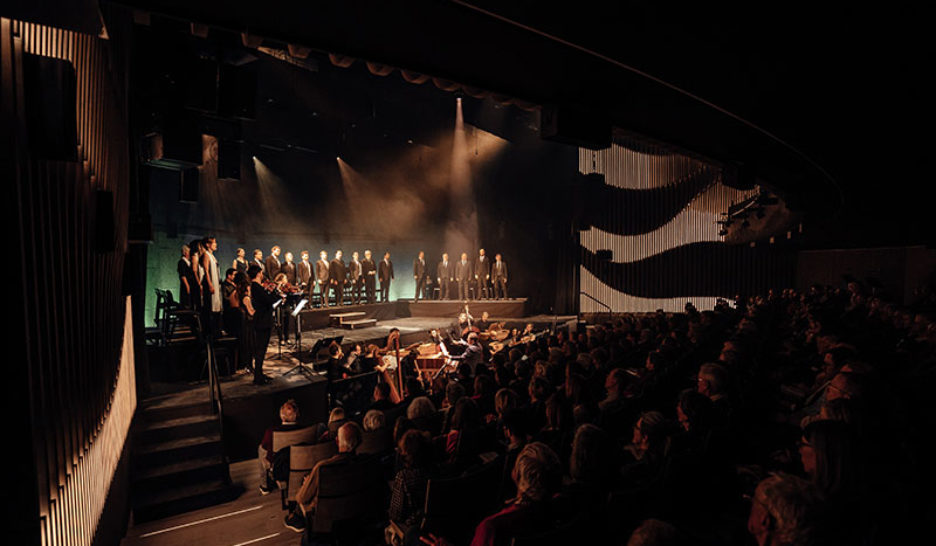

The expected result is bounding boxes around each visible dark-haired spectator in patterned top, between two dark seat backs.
[389,430,432,531]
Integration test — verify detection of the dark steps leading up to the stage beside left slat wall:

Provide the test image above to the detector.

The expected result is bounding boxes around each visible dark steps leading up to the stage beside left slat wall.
[131,402,239,522]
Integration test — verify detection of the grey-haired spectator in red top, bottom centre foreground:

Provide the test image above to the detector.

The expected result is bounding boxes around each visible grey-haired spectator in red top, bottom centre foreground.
[471,442,562,546]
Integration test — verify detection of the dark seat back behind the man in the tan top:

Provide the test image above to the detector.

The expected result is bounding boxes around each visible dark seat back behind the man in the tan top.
[311,456,387,533]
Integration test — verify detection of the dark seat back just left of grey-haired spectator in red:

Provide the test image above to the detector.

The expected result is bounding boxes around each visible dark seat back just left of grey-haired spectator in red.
[422,459,503,544]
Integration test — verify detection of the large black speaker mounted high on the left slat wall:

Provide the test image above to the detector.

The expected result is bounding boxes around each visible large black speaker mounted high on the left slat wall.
[23,53,78,161]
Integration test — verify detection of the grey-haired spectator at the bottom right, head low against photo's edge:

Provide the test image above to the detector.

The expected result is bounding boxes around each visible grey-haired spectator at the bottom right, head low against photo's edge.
[747,474,816,546]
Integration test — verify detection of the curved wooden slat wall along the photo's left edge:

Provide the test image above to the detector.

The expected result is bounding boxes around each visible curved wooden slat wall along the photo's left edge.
[0,19,136,544]
